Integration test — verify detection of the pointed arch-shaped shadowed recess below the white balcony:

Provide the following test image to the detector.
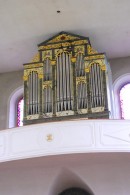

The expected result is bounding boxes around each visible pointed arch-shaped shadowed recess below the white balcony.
[48,168,94,195]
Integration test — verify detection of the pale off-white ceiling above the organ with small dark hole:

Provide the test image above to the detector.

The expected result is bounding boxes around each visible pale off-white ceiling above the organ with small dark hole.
[0,0,130,73]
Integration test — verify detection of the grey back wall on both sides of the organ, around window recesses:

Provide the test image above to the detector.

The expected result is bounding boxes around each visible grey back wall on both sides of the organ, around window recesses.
[0,57,130,130]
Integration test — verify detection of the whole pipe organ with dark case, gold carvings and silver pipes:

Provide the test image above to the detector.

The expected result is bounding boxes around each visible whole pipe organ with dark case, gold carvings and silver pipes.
[23,32,112,125]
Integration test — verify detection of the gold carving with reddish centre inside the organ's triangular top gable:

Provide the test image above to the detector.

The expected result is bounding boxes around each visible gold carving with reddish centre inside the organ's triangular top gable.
[48,34,80,43]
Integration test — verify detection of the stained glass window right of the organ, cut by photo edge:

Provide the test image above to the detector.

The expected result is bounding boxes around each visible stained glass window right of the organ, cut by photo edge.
[120,83,130,119]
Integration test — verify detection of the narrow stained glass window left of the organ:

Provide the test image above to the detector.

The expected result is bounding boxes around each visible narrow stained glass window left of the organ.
[17,97,24,127]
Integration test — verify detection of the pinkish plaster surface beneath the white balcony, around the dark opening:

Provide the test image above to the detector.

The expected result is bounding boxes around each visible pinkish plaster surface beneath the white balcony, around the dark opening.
[0,153,130,195]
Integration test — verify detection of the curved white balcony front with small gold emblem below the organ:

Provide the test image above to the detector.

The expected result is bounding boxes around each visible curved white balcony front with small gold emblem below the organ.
[0,120,130,162]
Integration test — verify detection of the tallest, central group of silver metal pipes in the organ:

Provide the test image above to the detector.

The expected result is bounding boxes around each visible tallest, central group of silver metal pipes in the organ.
[56,52,72,111]
